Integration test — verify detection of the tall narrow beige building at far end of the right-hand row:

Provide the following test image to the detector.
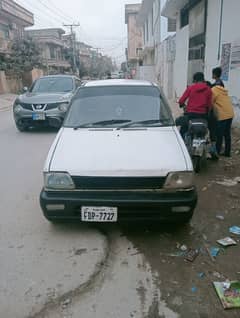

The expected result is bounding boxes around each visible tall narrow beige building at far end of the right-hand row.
[125,3,143,76]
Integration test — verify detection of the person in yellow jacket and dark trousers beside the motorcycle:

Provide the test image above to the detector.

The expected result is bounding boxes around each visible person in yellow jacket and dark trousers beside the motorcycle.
[212,85,234,157]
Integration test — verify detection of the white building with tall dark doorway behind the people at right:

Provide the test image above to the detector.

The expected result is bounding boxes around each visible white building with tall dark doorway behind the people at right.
[162,0,240,98]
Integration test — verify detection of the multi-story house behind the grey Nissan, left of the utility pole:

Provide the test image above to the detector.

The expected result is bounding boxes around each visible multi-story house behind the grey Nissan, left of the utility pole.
[26,28,71,74]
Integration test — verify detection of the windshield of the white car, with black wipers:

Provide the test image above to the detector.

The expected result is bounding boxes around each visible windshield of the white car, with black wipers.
[64,86,174,129]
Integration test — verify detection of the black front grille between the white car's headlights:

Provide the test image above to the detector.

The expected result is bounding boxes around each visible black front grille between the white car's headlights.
[72,176,166,190]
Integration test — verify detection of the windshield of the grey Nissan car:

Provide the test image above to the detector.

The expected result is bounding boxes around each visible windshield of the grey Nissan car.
[30,77,73,93]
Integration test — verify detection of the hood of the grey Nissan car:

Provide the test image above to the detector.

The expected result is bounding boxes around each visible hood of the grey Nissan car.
[18,93,72,104]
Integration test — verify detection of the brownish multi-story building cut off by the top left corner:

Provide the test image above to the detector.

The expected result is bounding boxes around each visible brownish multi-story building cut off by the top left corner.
[0,0,34,55]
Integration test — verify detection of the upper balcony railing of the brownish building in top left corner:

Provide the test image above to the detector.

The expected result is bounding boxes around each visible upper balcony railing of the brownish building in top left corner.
[0,0,34,26]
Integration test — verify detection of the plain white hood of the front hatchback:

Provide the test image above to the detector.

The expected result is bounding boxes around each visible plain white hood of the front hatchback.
[45,127,192,176]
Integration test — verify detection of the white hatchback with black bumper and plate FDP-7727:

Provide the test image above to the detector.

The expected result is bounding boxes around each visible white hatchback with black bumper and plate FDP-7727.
[40,80,197,222]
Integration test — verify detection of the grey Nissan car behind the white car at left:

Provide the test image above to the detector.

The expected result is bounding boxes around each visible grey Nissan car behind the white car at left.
[13,75,81,131]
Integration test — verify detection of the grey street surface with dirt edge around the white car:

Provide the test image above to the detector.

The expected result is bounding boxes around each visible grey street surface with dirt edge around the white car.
[0,103,240,318]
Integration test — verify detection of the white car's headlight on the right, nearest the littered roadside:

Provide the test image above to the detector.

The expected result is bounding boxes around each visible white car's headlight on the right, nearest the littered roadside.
[164,171,194,189]
